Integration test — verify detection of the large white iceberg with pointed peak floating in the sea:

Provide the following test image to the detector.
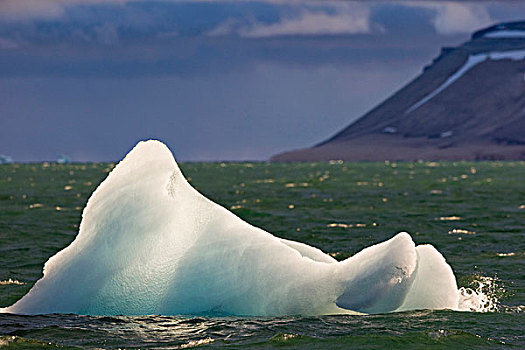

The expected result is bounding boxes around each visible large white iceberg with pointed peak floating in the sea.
[0,141,474,316]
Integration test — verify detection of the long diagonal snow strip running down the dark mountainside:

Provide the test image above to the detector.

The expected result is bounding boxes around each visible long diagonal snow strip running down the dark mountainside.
[405,50,525,114]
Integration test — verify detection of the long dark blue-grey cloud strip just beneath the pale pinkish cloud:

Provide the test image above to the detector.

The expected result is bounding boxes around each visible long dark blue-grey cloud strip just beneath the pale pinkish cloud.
[0,37,446,77]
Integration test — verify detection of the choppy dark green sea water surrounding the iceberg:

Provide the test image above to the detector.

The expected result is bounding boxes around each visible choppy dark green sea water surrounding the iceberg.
[0,162,525,349]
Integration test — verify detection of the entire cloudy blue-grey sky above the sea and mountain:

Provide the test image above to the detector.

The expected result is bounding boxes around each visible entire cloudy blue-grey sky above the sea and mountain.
[0,0,525,162]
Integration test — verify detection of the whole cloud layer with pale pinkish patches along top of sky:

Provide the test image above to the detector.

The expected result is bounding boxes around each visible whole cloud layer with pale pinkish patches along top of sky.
[0,0,496,77]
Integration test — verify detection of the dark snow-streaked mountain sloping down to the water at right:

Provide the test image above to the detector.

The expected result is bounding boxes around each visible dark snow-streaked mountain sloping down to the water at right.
[271,22,525,161]
